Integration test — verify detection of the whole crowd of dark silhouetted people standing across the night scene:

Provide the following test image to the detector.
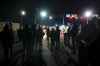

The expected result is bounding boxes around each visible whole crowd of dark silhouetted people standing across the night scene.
[0,17,99,65]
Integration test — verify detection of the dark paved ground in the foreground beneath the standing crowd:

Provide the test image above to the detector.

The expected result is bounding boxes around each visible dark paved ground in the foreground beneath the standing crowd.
[0,34,78,66]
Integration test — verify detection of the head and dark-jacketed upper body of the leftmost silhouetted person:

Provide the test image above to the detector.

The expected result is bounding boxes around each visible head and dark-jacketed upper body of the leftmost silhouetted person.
[1,25,14,46]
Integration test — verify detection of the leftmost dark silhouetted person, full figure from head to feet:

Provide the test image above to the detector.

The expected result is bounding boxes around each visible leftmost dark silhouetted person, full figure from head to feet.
[1,24,14,60]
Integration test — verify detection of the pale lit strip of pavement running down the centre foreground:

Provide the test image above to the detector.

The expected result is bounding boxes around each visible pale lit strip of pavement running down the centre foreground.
[42,40,57,66]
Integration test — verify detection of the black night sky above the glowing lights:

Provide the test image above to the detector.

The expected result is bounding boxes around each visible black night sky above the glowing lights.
[0,0,100,17]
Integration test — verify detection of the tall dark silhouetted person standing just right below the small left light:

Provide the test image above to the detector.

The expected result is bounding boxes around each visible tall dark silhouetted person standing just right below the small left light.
[23,25,32,59]
